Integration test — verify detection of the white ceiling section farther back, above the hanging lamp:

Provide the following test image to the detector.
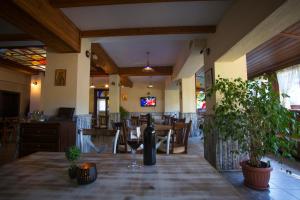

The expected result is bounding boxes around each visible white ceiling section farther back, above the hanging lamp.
[95,35,205,67]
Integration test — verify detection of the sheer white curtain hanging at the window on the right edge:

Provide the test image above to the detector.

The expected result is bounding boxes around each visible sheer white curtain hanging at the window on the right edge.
[277,65,300,109]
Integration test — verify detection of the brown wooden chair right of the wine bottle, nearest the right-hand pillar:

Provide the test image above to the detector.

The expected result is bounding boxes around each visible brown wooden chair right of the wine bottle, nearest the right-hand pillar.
[171,120,192,154]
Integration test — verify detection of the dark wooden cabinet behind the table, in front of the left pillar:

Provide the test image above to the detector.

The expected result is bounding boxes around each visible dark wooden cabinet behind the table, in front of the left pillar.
[19,121,76,157]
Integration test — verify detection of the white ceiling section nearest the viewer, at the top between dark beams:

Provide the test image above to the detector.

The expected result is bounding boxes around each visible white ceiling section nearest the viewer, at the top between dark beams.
[62,0,231,30]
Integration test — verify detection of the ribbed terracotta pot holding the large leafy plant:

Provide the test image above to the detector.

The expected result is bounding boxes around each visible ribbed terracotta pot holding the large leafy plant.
[240,160,273,190]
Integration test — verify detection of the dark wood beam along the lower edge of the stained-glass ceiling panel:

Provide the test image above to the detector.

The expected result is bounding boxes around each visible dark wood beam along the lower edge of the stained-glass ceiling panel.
[0,58,41,75]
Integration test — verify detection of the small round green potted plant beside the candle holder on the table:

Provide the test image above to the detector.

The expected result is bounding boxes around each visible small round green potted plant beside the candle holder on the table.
[65,146,80,179]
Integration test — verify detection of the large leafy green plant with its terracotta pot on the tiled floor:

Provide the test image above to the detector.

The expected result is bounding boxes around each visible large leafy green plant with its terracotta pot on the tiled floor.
[206,77,299,190]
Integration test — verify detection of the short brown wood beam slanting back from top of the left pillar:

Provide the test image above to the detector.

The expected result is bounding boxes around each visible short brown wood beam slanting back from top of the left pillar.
[91,43,118,74]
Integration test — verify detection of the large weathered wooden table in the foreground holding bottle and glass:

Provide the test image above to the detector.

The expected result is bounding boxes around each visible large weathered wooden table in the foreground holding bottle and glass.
[0,152,241,200]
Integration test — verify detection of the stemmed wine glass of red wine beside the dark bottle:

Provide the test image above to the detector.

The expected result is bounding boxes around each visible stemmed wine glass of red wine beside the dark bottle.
[127,127,143,168]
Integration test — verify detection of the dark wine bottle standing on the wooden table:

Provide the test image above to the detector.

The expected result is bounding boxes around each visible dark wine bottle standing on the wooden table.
[144,114,156,165]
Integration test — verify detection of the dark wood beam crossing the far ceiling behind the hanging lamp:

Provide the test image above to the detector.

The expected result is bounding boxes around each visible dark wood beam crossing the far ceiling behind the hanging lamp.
[119,66,173,76]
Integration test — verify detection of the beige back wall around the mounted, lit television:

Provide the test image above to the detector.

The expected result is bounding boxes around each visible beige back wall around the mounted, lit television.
[121,82,164,112]
